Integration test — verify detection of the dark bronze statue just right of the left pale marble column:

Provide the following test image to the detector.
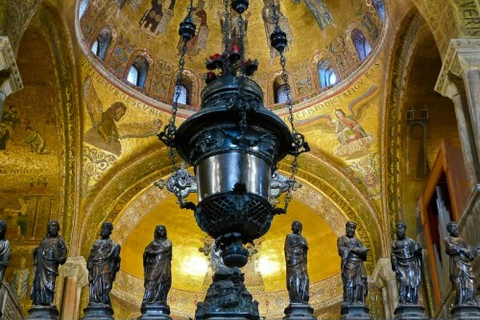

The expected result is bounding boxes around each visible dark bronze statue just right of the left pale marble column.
[87,221,121,307]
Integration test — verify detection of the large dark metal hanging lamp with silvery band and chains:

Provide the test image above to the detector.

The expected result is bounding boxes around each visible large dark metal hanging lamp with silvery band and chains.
[157,0,309,267]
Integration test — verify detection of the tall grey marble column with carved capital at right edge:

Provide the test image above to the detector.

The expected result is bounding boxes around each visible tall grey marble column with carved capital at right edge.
[435,39,480,243]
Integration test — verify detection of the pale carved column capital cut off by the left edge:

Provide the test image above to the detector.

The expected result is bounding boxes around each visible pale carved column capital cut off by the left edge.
[0,36,23,119]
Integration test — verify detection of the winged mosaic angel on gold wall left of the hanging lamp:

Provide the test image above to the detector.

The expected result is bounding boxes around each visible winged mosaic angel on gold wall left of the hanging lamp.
[83,76,162,156]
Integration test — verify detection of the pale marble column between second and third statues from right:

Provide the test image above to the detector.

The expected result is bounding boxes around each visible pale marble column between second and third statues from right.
[372,258,398,319]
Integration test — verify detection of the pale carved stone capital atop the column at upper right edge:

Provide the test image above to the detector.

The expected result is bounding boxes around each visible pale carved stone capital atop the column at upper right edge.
[435,39,480,98]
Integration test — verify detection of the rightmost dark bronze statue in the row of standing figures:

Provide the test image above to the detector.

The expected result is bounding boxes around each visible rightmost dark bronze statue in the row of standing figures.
[444,222,478,305]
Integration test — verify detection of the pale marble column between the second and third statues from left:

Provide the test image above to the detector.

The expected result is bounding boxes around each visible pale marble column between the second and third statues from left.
[57,256,88,320]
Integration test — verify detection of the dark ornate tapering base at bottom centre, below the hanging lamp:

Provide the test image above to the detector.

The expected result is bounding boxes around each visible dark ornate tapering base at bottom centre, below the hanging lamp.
[195,268,260,320]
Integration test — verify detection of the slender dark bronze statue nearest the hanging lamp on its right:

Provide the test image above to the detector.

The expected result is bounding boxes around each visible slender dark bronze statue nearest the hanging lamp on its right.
[284,221,310,304]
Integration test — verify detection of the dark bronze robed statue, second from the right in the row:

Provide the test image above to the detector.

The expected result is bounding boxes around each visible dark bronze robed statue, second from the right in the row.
[391,221,422,304]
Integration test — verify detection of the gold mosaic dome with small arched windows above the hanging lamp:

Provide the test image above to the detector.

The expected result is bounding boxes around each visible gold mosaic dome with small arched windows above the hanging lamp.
[79,0,382,108]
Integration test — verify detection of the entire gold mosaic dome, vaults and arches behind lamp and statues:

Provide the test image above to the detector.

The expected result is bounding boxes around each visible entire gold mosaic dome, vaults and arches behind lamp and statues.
[0,0,474,319]
